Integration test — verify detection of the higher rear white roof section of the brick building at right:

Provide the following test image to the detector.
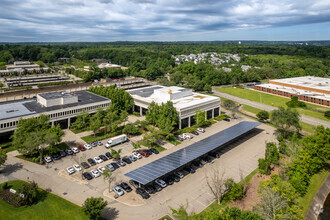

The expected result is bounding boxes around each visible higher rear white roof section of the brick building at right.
[269,76,330,91]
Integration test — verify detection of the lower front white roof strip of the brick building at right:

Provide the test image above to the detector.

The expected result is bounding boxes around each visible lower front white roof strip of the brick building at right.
[258,84,330,101]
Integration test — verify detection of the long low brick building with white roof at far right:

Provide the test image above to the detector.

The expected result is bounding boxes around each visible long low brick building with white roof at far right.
[254,76,330,106]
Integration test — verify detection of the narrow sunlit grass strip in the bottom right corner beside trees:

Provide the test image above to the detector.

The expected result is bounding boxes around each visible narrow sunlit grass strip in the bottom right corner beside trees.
[298,171,330,217]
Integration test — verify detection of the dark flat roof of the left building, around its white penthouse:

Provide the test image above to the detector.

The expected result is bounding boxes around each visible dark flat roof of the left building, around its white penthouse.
[0,91,110,120]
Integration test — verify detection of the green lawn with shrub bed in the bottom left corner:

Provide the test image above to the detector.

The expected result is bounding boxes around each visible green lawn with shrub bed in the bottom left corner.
[0,180,88,220]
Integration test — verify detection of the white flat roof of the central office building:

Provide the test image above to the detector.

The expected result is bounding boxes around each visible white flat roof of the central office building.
[127,85,220,109]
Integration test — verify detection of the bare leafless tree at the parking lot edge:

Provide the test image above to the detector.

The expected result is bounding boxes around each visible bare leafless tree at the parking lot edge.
[206,169,225,205]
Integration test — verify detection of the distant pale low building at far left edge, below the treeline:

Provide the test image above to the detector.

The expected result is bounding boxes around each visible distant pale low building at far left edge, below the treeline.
[0,61,49,76]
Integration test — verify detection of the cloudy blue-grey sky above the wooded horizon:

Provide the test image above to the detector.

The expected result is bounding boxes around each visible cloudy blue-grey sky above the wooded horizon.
[0,0,330,42]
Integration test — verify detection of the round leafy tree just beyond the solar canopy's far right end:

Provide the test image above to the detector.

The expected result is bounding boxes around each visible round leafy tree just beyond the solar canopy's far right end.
[270,107,301,138]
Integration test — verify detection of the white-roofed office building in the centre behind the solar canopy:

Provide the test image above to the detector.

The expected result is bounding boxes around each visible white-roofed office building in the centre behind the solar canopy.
[127,85,220,129]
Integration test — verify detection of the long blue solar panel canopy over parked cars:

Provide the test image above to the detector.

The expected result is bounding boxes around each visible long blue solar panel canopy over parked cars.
[125,121,261,185]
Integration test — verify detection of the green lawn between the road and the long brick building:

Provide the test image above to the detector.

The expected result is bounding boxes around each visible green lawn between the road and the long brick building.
[217,87,330,121]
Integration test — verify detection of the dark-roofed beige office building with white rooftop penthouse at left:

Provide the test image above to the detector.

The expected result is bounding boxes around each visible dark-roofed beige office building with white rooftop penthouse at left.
[0,91,111,135]
